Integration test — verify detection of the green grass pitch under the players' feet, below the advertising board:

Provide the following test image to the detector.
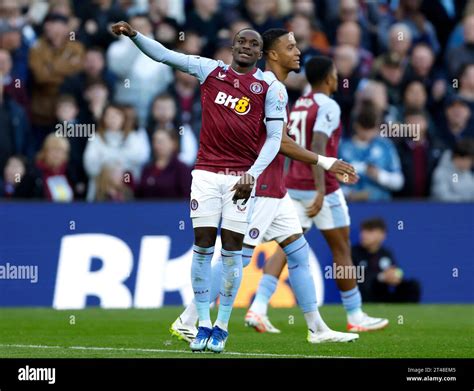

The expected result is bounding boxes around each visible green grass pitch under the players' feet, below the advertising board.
[0,304,474,358]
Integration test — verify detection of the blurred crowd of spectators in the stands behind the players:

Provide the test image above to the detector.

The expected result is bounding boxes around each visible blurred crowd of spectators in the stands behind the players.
[0,0,474,201]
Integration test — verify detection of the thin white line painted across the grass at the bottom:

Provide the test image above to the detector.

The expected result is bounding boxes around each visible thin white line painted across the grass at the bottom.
[0,344,354,358]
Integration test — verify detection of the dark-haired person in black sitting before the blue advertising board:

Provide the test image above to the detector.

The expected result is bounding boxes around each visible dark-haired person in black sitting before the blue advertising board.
[352,218,421,303]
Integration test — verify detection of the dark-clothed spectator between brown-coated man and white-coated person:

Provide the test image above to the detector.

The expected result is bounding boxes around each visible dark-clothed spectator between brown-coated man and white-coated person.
[61,46,115,118]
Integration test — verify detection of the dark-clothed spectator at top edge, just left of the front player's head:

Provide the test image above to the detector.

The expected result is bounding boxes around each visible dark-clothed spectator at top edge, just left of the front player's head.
[185,0,227,57]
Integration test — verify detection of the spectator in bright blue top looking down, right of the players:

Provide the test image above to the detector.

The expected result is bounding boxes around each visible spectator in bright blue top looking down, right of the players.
[339,101,404,201]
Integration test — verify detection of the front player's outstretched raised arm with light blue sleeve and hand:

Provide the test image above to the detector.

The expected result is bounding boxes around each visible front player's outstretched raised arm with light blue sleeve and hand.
[112,22,220,83]
